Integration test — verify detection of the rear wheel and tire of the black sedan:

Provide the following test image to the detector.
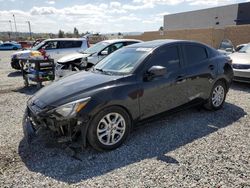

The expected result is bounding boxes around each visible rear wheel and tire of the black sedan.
[204,81,227,110]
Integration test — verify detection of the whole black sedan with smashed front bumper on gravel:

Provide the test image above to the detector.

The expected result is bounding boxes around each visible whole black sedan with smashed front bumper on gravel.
[23,40,233,150]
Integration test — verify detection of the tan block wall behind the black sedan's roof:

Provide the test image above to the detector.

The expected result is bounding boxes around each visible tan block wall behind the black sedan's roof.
[124,25,250,48]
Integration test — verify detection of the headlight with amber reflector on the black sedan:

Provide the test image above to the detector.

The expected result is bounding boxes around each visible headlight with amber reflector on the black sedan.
[54,97,91,117]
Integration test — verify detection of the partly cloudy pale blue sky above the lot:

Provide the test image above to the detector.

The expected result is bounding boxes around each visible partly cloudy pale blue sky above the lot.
[0,0,249,33]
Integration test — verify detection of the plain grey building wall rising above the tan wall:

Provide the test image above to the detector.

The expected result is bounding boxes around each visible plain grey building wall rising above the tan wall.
[164,4,238,30]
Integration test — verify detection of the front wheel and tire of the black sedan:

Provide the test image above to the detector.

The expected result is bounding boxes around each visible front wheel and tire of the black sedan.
[87,106,131,151]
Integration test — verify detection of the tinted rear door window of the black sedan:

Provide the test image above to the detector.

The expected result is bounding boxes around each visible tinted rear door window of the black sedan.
[185,45,208,65]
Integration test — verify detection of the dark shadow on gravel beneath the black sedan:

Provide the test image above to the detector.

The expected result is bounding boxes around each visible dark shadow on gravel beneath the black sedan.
[19,103,246,184]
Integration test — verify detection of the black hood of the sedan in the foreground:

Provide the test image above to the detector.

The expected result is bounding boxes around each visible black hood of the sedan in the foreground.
[28,71,122,108]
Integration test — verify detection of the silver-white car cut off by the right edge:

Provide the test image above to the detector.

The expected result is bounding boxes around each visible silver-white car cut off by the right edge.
[229,44,250,83]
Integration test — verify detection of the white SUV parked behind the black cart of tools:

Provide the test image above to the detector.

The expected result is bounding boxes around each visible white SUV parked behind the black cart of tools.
[11,38,89,70]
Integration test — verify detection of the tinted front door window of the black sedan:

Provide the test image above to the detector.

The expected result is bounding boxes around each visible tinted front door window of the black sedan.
[147,46,180,71]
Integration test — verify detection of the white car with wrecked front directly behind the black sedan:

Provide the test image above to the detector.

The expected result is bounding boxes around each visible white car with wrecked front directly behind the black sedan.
[55,39,142,77]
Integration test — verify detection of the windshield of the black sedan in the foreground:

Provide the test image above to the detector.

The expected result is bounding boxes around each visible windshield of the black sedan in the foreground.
[93,48,149,74]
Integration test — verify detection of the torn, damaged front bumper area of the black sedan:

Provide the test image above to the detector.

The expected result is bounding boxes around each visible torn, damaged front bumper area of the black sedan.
[22,108,87,147]
